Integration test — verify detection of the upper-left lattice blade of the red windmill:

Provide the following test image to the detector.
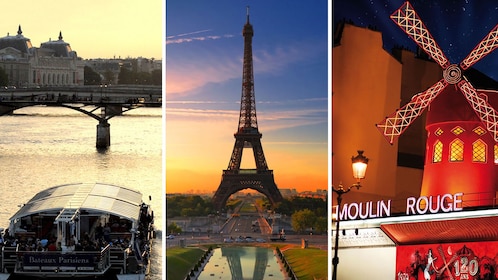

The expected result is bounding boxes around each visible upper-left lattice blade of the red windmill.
[391,1,450,69]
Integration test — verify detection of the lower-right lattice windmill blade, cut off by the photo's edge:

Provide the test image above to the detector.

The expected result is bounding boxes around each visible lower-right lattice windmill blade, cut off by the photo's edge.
[458,80,498,142]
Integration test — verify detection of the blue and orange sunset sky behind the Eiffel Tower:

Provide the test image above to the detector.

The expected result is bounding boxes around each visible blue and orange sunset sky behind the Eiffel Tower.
[166,0,330,193]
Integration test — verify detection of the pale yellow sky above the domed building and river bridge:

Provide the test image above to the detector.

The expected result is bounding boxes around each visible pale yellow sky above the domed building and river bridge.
[0,0,164,59]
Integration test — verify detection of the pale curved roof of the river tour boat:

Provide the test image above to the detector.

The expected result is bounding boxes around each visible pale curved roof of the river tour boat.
[10,183,142,224]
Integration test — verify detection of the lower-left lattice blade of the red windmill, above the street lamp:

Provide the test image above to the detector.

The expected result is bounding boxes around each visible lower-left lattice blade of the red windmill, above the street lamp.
[376,79,448,144]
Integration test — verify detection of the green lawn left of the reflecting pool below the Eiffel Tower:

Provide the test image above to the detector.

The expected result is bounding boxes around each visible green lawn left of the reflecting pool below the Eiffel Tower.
[166,247,204,280]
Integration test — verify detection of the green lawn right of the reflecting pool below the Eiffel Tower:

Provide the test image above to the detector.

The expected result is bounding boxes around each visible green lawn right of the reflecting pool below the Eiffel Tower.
[283,248,328,280]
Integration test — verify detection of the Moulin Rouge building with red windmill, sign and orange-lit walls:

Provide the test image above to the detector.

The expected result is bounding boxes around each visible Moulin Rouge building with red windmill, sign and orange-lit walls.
[332,3,498,280]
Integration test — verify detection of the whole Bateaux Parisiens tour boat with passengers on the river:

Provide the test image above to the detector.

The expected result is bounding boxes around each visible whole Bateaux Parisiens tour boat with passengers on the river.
[0,183,155,279]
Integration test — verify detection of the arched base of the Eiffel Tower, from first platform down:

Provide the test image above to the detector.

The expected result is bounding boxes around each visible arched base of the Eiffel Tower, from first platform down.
[213,172,283,211]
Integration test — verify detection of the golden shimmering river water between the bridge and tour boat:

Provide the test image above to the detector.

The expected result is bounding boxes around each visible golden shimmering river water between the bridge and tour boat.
[0,104,164,279]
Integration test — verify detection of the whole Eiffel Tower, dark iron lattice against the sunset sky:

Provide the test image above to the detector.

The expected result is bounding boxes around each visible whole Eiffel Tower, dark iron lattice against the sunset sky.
[213,7,282,210]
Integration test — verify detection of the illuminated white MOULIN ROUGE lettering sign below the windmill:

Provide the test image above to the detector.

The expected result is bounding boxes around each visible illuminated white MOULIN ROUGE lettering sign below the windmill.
[334,193,463,221]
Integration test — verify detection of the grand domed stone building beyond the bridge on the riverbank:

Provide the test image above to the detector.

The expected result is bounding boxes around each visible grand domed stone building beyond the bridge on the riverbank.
[0,25,84,87]
